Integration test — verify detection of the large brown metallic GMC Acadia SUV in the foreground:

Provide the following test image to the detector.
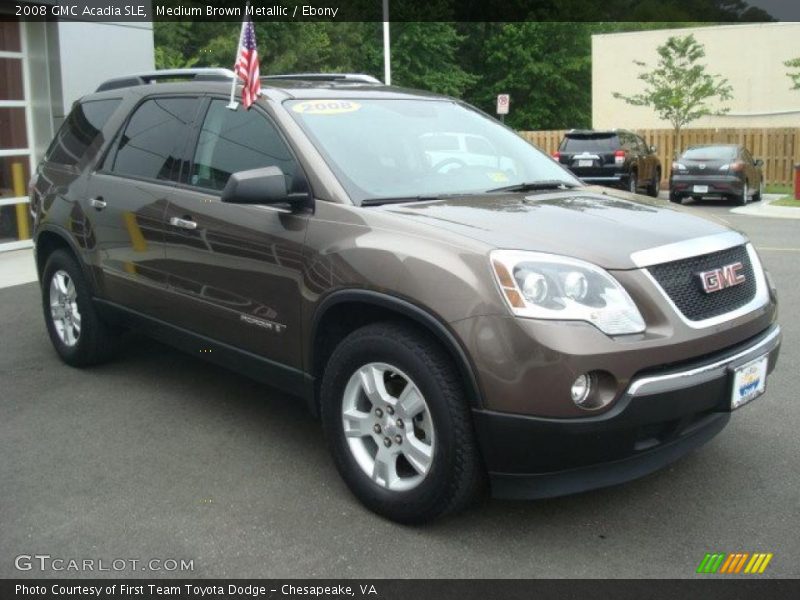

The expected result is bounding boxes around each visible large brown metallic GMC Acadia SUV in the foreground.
[31,70,781,523]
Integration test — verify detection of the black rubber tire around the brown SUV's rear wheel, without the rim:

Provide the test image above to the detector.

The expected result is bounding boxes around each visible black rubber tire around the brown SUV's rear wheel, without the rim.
[42,250,119,367]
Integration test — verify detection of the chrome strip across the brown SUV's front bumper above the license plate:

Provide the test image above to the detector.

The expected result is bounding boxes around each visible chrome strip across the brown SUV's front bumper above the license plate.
[625,324,781,396]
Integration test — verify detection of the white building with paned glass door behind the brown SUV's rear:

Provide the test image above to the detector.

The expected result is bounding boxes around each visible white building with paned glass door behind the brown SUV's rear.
[0,10,154,251]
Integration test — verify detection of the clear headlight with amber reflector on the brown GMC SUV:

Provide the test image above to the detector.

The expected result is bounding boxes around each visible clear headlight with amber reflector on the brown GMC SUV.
[489,250,645,335]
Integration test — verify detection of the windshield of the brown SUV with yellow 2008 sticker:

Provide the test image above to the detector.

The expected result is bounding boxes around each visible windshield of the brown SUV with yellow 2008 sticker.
[287,98,580,204]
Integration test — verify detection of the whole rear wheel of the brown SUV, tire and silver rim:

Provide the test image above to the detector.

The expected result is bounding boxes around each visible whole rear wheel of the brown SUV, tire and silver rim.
[42,250,116,367]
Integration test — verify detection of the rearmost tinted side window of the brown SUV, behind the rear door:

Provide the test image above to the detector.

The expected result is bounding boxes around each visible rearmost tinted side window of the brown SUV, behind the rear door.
[44,98,121,165]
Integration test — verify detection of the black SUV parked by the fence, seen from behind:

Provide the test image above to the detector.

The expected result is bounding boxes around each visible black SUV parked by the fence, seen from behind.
[553,129,662,197]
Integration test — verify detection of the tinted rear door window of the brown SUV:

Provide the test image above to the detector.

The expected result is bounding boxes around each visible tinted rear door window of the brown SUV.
[111,98,197,179]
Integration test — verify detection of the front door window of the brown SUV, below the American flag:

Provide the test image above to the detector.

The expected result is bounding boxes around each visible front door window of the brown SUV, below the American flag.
[189,100,297,190]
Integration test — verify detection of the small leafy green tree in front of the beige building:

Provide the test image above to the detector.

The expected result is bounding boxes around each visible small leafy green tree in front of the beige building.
[614,35,733,152]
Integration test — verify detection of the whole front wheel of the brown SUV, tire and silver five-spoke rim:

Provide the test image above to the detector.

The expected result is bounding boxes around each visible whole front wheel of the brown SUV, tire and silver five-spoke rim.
[321,322,484,524]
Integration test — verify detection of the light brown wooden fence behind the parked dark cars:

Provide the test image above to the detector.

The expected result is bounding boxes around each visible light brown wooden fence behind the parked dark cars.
[520,127,800,185]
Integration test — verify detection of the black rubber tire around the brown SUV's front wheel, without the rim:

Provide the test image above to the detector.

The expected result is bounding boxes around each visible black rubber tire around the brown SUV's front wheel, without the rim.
[320,321,485,524]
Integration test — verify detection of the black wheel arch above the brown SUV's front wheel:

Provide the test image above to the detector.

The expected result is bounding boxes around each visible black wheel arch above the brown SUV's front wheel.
[306,289,482,414]
